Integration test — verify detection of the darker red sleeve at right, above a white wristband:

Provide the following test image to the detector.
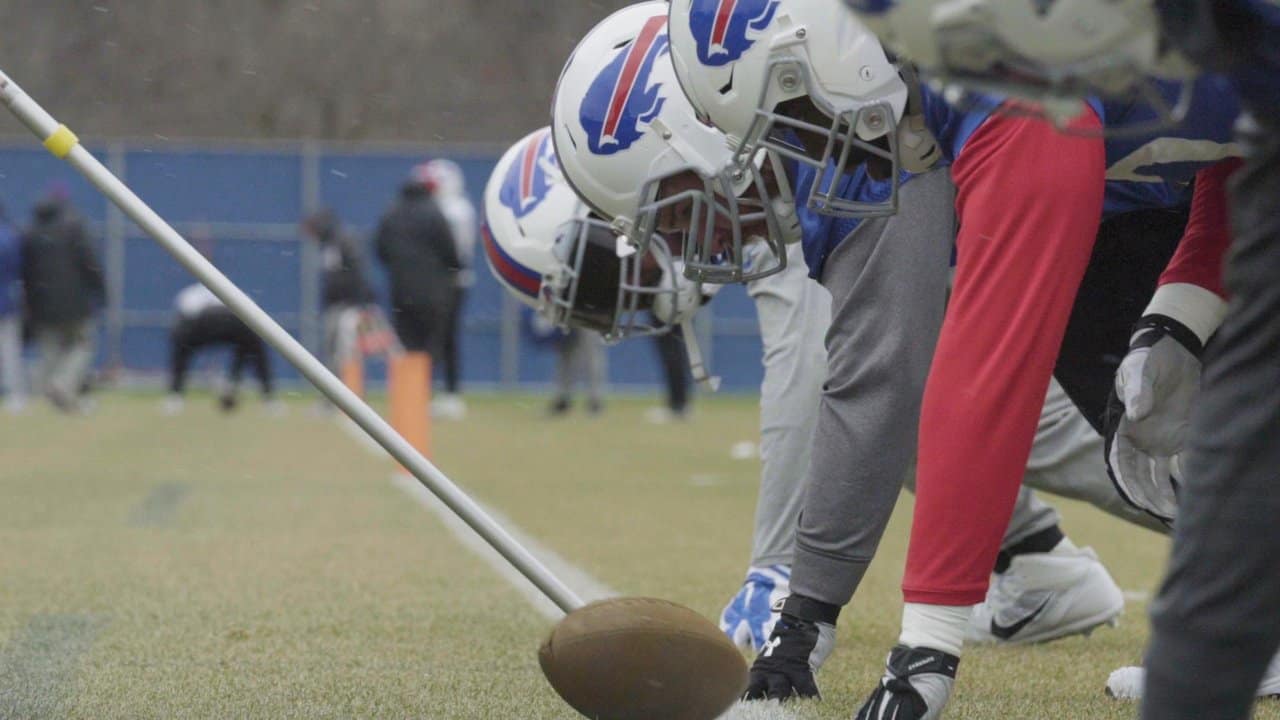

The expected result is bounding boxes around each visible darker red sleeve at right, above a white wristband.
[1160,158,1243,299]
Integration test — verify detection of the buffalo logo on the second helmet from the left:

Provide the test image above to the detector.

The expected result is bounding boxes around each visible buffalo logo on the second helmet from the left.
[579,15,671,155]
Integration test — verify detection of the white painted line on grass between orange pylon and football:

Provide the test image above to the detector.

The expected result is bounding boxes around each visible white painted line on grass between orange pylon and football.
[392,473,618,620]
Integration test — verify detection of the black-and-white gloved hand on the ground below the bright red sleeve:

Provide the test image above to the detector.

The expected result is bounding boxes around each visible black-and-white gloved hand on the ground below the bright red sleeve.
[854,644,960,720]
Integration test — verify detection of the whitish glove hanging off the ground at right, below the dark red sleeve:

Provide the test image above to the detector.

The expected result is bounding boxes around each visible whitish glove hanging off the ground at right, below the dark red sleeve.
[1107,315,1201,523]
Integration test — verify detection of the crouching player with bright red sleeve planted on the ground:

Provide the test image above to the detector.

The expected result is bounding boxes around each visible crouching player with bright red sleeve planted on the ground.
[672,0,1236,717]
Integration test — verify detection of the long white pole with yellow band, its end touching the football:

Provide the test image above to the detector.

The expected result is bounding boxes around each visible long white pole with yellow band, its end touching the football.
[0,70,582,612]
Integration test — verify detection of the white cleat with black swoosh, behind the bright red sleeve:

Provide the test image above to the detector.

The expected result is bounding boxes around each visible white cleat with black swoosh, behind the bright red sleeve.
[968,539,1124,644]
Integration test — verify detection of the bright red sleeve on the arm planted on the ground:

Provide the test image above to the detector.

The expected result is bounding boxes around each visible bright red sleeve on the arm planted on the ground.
[902,113,1106,605]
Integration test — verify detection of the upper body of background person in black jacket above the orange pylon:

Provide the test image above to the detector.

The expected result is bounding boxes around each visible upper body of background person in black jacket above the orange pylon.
[374,169,461,356]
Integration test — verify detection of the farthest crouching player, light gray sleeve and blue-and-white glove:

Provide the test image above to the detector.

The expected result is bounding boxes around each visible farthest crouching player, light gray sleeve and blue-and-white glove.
[484,122,831,650]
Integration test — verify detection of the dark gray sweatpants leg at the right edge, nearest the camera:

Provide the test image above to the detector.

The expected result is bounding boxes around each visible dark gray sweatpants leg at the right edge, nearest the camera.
[1142,113,1280,720]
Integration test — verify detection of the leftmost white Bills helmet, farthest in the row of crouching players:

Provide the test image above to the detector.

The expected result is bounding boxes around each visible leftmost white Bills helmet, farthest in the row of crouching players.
[481,128,701,341]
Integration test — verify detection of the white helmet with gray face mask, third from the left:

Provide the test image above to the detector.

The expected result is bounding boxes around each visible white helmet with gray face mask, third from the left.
[671,0,941,217]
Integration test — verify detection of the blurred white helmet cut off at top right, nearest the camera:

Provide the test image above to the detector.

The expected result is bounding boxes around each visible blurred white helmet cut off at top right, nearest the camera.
[849,0,1194,126]
